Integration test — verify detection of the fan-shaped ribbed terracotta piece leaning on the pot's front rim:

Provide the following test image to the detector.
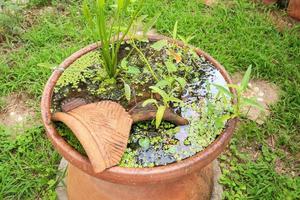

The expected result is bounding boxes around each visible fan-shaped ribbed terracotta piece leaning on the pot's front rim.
[52,101,133,173]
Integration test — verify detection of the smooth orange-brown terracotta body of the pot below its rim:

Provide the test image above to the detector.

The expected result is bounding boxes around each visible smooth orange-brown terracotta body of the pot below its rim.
[67,164,213,200]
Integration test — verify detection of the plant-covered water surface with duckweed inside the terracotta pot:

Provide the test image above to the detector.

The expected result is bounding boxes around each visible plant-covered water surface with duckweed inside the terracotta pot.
[52,39,232,167]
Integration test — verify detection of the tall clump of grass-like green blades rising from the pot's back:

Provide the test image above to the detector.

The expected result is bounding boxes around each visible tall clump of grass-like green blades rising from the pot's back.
[83,0,144,78]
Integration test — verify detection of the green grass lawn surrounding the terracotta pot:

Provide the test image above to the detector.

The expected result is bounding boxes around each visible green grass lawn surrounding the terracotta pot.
[0,0,300,199]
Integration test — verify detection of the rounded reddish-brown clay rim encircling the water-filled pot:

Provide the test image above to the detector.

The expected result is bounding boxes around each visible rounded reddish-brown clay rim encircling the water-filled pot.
[41,34,237,184]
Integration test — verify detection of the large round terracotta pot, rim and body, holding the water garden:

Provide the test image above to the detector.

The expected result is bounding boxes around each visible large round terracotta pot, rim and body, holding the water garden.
[41,35,237,200]
